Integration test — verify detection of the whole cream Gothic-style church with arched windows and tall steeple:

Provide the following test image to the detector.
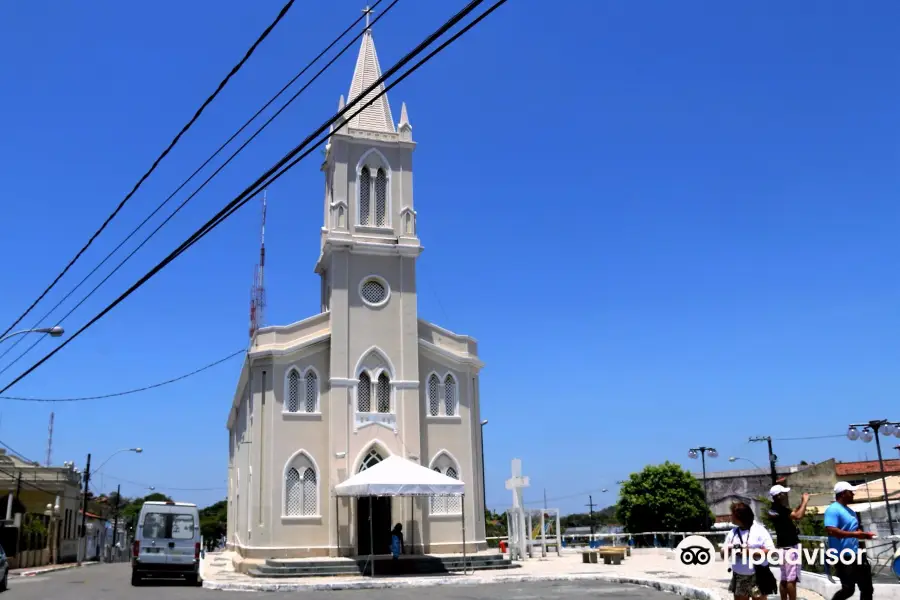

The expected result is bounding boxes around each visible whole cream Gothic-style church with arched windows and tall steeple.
[227,18,487,562]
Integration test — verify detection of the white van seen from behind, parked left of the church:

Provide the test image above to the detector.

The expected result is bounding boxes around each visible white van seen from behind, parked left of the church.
[131,502,200,585]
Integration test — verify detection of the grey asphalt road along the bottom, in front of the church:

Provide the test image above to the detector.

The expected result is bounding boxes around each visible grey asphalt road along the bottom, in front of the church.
[0,564,676,600]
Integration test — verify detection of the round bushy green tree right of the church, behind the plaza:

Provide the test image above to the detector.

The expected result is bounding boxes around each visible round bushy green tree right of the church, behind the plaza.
[616,461,714,533]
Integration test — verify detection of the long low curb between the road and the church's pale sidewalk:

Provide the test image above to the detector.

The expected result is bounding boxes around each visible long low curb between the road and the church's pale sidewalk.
[203,573,723,600]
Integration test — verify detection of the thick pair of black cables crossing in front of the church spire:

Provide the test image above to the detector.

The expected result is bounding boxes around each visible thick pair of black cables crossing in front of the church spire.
[0,0,507,394]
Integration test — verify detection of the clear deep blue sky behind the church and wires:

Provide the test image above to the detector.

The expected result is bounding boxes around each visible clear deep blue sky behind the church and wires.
[0,0,900,510]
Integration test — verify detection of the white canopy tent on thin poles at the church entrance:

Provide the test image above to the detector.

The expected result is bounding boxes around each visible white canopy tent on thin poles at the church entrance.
[334,456,466,575]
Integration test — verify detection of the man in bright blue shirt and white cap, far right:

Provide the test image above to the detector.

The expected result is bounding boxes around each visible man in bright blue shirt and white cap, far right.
[825,481,875,600]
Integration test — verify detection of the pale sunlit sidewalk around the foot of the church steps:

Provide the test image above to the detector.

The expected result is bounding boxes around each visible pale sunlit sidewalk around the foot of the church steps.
[201,549,824,600]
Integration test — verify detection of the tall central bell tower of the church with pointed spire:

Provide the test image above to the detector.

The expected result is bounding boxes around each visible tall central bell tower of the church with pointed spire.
[316,17,422,460]
